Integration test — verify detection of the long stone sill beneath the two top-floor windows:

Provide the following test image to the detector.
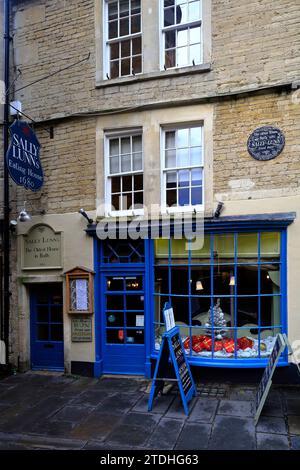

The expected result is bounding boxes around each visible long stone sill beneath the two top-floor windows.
[96,64,211,88]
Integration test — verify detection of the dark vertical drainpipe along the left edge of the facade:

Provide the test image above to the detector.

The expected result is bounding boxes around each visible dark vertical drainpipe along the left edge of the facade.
[1,0,11,368]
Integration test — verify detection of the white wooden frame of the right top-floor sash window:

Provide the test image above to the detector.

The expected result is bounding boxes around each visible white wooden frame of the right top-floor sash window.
[159,0,206,70]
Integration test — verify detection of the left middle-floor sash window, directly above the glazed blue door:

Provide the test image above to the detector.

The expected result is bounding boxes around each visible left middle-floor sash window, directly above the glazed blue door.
[106,131,144,214]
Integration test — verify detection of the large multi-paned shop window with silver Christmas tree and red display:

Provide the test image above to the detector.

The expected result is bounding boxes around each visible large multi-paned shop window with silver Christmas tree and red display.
[154,232,283,359]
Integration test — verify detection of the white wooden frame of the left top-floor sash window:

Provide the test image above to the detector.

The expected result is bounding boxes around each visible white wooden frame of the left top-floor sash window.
[103,0,144,80]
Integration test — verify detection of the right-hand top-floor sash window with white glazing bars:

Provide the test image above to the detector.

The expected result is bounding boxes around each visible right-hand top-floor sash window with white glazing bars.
[162,0,203,69]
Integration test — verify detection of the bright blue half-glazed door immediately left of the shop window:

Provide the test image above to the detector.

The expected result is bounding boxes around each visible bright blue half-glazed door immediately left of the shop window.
[101,273,145,375]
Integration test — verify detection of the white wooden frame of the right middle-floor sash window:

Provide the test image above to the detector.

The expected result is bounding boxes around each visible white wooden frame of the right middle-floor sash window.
[160,121,205,214]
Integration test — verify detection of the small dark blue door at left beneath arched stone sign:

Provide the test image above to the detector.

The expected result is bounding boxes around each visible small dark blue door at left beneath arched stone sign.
[30,284,64,370]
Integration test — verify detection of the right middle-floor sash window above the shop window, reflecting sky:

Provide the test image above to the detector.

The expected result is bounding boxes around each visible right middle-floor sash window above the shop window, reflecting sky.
[162,126,204,211]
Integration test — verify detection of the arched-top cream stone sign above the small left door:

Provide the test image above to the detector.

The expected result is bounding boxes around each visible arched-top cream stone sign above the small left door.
[22,224,62,269]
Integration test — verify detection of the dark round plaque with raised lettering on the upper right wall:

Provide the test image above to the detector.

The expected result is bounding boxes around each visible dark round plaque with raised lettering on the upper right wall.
[247,126,285,161]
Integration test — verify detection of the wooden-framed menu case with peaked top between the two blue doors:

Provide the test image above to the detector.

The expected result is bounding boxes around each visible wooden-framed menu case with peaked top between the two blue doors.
[65,267,93,314]
